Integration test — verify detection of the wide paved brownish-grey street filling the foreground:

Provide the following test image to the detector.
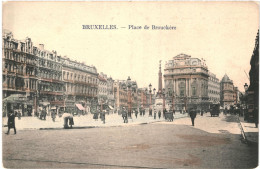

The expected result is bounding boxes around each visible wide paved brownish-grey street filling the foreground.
[3,114,258,168]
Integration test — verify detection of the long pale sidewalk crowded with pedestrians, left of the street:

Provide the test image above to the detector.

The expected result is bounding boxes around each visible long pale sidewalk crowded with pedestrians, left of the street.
[2,113,187,132]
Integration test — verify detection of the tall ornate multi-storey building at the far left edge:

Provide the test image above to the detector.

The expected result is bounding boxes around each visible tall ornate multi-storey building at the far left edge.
[2,30,38,116]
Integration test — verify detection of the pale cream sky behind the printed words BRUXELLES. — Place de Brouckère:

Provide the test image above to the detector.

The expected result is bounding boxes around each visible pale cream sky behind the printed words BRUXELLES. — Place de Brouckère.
[3,2,259,91]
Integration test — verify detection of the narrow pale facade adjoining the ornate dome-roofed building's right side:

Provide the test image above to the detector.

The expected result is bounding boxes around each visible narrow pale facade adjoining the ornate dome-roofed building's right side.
[208,72,220,104]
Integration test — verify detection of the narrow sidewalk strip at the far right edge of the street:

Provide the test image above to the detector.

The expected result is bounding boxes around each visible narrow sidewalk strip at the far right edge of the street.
[239,117,259,144]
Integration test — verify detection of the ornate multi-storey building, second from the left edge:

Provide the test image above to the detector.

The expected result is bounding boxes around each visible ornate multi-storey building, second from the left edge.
[34,44,64,115]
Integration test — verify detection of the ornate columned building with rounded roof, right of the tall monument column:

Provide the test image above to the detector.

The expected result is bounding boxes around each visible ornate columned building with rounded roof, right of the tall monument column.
[164,54,209,110]
